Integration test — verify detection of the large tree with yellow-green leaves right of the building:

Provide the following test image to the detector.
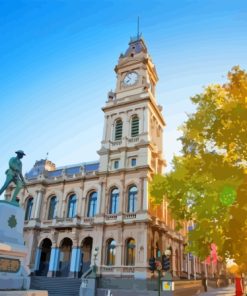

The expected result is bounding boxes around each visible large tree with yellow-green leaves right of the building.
[150,67,247,263]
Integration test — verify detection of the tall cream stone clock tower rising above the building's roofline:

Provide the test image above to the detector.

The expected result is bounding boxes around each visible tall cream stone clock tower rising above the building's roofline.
[98,35,165,175]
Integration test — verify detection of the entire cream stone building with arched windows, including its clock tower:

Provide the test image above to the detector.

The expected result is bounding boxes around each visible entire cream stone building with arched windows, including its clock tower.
[7,36,201,278]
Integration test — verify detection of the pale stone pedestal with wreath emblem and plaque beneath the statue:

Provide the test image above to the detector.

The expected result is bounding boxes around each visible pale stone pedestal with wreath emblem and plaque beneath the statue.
[0,200,30,290]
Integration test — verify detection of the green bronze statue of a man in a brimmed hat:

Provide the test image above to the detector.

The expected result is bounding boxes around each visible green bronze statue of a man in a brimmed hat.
[0,150,26,203]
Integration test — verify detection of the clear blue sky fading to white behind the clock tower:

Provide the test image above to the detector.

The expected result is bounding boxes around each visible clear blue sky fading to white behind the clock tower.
[0,0,247,187]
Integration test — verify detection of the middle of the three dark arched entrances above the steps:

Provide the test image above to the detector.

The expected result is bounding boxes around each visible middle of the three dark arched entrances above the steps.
[59,237,73,277]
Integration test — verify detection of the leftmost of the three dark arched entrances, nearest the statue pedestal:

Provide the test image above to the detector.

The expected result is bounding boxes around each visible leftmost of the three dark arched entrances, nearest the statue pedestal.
[37,238,52,276]
